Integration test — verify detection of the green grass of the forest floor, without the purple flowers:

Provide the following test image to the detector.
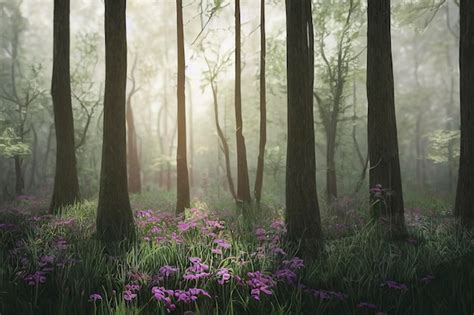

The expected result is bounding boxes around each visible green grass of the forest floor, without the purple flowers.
[0,199,474,315]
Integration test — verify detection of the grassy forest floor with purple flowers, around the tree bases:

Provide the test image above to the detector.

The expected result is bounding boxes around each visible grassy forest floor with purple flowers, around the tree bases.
[0,195,474,315]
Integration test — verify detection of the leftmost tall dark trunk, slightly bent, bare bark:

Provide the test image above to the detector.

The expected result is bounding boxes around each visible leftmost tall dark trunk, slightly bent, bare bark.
[50,0,79,213]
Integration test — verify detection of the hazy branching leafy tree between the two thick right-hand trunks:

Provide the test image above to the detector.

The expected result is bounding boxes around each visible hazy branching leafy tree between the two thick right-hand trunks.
[314,0,360,203]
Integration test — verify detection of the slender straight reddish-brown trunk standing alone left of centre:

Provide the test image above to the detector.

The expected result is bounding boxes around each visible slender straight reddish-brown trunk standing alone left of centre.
[176,0,190,215]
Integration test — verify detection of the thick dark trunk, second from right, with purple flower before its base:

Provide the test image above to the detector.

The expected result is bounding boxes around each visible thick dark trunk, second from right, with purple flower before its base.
[367,0,406,237]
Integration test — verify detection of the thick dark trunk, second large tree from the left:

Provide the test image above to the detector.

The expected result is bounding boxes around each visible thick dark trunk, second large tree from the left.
[97,0,135,241]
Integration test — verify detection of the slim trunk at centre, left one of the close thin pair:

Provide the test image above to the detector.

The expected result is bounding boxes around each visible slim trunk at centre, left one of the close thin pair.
[235,0,252,208]
